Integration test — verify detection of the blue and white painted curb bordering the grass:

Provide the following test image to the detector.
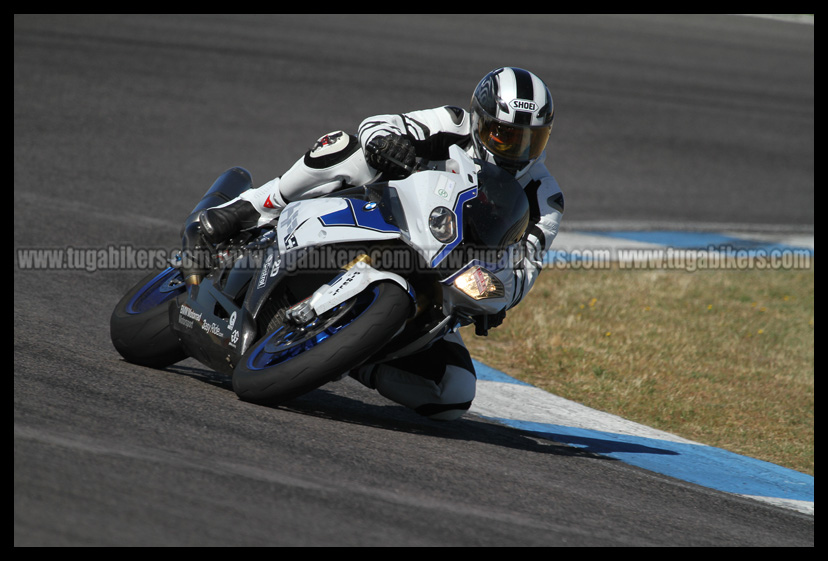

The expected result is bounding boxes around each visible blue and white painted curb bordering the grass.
[471,226,814,515]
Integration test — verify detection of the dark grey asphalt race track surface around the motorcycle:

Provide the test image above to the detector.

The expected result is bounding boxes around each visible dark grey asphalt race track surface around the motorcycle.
[14,15,814,546]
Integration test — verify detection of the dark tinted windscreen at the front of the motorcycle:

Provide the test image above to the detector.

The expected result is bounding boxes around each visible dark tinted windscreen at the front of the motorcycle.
[463,160,529,252]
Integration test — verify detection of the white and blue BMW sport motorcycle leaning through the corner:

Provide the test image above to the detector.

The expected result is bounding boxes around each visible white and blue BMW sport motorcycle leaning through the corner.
[110,146,529,404]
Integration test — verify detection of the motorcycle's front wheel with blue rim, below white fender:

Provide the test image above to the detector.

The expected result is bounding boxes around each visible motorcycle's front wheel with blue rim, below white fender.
[233,282,411,404]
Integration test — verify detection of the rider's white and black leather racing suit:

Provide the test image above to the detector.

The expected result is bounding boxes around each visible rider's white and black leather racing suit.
[230,106,564,420]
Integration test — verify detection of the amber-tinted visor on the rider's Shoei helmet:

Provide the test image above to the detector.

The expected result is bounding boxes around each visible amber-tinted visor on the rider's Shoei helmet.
[477,114,552,162]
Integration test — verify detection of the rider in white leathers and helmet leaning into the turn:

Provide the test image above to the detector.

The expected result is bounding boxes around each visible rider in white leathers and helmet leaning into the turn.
[187,67,564,420]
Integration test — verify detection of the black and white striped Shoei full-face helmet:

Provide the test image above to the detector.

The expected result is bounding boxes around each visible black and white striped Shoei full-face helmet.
[470,67,554,178]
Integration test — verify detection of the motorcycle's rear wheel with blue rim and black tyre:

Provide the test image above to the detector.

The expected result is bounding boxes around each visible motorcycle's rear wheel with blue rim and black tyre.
[109,267,187,368]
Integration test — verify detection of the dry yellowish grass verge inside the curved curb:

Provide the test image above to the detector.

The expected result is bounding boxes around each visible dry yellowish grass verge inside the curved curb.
[463,259,814,475]
